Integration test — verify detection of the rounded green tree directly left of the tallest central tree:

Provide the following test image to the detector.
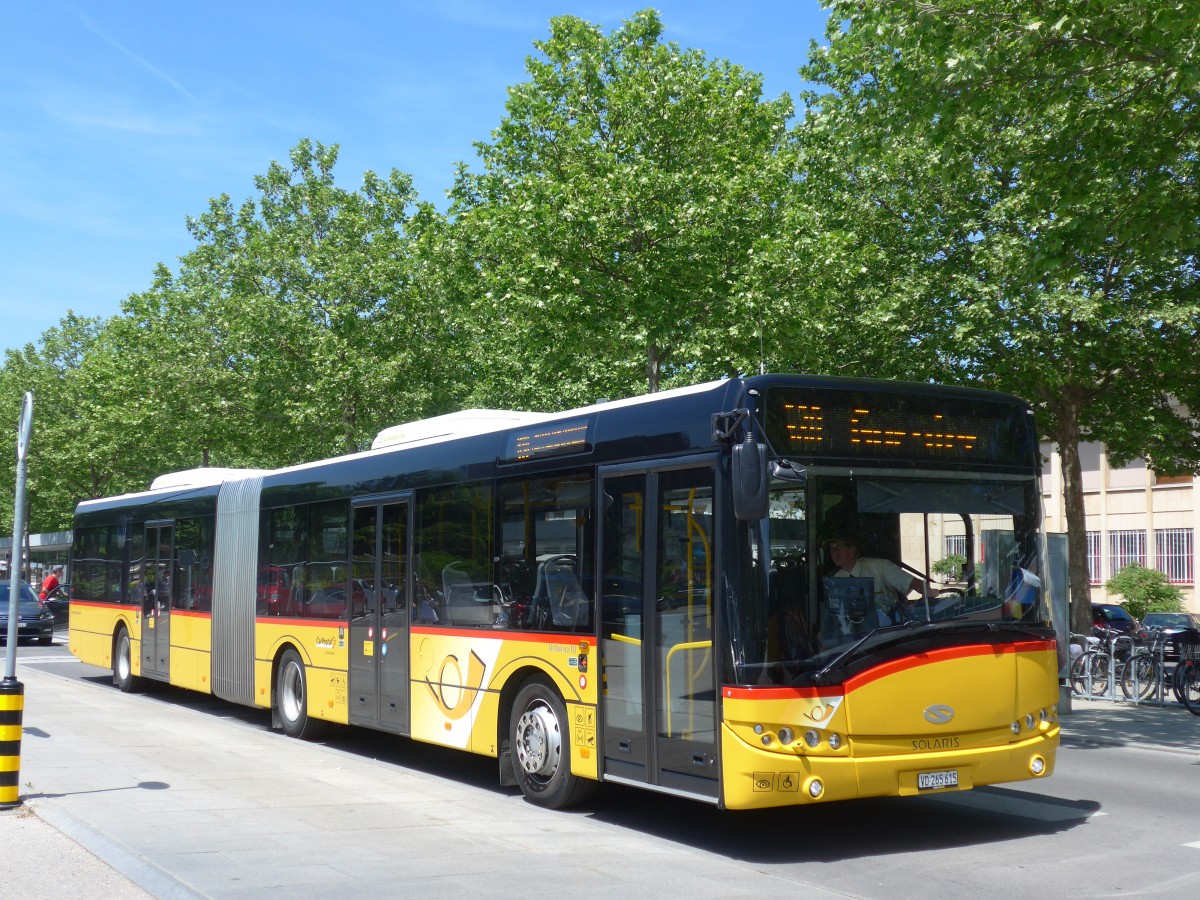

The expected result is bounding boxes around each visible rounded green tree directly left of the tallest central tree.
[175,140,458,464]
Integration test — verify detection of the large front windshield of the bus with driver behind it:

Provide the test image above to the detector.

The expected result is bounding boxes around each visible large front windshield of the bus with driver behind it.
[731,470,1049,684]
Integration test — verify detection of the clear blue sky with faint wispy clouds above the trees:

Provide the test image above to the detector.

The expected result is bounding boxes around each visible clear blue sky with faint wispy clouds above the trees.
[0,0,828,349]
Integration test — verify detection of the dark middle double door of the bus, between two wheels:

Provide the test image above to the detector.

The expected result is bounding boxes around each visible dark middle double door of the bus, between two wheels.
[347,499,413,734]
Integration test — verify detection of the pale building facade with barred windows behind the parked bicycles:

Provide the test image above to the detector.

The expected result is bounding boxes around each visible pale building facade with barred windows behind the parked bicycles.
[1042,443,1200,612]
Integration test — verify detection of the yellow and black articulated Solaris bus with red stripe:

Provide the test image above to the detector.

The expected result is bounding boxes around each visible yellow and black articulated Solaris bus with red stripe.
[70,376,1058,809]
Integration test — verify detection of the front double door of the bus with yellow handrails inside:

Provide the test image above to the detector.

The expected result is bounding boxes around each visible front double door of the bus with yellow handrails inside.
[600,464,719,798]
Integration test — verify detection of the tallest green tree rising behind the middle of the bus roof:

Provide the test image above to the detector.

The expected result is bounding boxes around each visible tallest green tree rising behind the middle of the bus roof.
[451,10,792,404]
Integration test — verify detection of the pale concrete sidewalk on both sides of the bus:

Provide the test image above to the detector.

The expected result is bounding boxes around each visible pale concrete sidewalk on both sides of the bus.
[0,667,1200,900]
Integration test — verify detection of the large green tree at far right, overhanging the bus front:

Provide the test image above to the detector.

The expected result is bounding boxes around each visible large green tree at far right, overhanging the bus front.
[798,0,1200,630]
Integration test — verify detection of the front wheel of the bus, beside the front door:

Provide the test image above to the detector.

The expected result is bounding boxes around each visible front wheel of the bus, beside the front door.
[509,678,595,809]
